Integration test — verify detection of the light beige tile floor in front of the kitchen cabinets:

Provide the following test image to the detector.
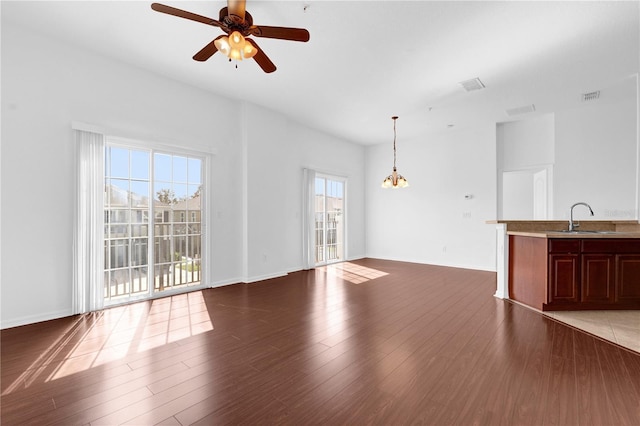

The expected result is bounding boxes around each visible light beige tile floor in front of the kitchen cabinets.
[543,310,640,352]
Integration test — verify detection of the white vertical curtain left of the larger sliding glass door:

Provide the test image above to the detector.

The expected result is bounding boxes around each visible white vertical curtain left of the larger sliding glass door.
[72,128,105,314]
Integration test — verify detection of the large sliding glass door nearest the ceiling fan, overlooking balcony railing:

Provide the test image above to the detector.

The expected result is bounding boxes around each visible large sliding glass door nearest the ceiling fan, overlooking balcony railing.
[103,140,206,306]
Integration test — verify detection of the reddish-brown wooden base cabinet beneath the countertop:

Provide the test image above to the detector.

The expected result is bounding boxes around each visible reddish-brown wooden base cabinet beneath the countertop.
[509,235,640,311]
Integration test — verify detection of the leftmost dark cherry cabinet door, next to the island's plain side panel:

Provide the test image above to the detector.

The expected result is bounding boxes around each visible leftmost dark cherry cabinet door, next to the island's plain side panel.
[548,254,580,303]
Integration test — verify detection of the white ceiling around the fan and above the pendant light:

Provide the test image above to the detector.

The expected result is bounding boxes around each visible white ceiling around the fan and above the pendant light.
[1,0,640,144]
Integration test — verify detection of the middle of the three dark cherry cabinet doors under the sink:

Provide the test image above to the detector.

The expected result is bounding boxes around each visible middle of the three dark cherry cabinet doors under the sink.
[580,254,615,303]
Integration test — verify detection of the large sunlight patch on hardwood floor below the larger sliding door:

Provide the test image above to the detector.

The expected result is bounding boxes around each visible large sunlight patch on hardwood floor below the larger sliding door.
[3,291,214,395]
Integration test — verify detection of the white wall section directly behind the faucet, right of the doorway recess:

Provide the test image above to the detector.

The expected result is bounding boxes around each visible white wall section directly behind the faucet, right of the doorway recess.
[554,77,638,220]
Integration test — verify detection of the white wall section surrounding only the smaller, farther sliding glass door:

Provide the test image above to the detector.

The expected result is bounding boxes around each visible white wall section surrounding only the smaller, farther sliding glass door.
[245,105,365,282]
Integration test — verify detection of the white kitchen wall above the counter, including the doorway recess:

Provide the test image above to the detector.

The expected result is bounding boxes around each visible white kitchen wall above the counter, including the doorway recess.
[497,76,639,220]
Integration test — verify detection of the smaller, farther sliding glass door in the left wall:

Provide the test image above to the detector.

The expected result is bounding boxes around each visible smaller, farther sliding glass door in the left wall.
[315,175,346,265]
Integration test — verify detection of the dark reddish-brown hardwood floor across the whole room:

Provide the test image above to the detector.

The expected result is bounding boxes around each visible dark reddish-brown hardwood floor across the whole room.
[0,259,640,425]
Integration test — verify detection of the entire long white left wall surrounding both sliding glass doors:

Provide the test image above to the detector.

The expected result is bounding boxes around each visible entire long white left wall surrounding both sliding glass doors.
[0,22,364,328]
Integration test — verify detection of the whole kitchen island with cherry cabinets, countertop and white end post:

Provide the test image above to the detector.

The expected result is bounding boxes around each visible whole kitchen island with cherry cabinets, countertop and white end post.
[490,221,640,311]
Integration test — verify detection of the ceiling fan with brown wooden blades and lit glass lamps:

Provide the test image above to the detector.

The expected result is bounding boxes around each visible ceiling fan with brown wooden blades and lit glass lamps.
[151,0,309,73]
